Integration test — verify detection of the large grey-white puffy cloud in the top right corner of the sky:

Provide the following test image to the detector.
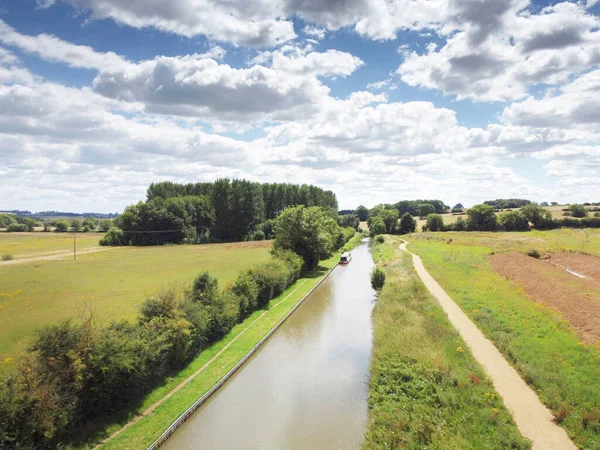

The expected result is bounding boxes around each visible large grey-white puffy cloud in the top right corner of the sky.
[397,0,600,101]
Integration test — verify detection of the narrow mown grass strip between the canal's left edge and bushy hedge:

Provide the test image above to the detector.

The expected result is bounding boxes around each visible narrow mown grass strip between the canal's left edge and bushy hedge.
[72,233,362,449]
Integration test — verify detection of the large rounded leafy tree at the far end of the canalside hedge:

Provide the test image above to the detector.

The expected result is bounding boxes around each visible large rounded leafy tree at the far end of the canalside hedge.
[273,206,341,270]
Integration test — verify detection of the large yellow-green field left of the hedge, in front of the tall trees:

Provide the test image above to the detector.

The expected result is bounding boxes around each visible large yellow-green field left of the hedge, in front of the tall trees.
[0,241,271,363]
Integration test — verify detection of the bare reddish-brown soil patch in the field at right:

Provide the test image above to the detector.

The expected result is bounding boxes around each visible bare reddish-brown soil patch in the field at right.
[490,253,600,344]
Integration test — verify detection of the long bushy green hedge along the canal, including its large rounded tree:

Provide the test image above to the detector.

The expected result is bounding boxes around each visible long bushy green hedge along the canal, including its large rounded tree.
[0,206,355,449]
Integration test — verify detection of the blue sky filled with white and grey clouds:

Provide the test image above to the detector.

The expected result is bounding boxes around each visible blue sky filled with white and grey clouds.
[0,0,600,212]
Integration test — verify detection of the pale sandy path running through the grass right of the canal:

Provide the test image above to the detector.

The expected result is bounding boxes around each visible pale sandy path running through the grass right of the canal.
[400,242,577,450]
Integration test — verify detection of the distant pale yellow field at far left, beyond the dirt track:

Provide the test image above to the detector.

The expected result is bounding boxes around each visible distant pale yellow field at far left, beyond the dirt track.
[0,232,104,259]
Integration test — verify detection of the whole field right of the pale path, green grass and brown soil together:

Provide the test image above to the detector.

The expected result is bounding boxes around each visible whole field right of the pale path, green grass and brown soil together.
[407,229,600,448]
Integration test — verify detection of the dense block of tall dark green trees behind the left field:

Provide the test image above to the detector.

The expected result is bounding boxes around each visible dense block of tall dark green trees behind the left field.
[101,178,338,245]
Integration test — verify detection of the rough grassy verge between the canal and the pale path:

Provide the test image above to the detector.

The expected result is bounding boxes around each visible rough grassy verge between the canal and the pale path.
[364,237,530,450]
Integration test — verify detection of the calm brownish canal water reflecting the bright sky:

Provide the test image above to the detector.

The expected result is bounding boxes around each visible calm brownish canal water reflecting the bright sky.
[161,240,375,450]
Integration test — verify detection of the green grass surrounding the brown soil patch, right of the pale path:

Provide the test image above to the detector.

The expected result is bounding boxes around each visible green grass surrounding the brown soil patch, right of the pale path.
[408,229,600,449]
